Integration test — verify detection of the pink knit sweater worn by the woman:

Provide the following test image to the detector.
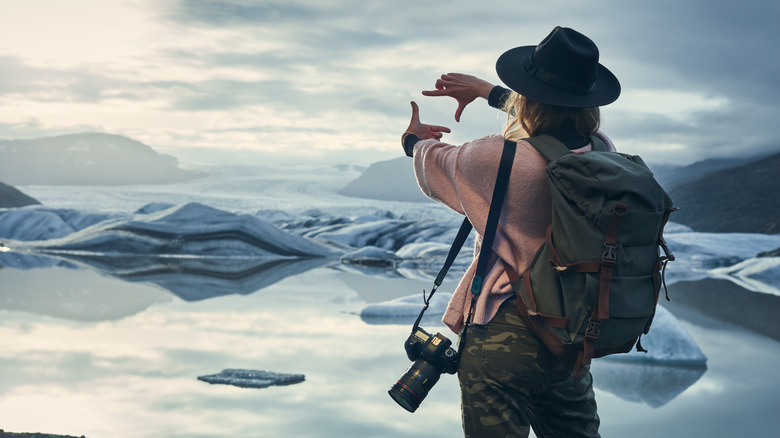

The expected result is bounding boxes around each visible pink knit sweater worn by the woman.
[414,133,615,333]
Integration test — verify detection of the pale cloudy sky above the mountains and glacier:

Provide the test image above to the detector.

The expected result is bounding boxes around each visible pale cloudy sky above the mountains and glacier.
[0,0,780,164]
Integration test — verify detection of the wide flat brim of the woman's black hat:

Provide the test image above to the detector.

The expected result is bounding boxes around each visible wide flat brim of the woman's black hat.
[496,46,620,108]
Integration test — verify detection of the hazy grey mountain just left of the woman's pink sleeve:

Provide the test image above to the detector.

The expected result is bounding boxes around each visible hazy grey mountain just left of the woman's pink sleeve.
[339,157,430,202]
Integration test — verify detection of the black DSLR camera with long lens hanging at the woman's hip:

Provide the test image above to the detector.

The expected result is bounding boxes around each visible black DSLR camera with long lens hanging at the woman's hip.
[388,328,459,412]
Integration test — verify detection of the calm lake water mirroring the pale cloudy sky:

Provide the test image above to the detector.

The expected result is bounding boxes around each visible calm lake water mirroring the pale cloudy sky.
[0,260,780,438]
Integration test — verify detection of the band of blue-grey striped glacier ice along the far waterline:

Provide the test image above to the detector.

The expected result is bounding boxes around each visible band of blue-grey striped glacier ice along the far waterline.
[0,202,780,295]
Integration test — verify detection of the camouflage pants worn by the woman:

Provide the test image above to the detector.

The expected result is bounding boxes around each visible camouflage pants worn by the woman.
[458,299,600,438]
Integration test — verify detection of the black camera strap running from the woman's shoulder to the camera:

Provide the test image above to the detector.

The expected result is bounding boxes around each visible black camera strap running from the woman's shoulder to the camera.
[412,139,517,336]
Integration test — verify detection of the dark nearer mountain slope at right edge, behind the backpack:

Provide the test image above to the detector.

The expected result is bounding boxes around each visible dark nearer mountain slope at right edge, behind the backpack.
[669,154,780,234]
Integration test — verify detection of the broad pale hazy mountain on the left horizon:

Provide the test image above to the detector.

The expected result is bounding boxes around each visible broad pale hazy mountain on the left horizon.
[0,133,197,185]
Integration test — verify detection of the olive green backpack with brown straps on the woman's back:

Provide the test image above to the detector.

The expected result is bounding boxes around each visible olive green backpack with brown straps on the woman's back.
[507,135,676,375]
